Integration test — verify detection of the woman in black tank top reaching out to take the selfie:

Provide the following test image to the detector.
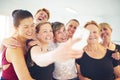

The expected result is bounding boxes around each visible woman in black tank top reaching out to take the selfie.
[27,22,81,80]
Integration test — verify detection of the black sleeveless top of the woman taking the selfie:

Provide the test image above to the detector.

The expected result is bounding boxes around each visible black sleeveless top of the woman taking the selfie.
[26,46,54,80]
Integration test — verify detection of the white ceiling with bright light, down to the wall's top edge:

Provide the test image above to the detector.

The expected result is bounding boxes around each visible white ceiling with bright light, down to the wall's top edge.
[0,0,120,19]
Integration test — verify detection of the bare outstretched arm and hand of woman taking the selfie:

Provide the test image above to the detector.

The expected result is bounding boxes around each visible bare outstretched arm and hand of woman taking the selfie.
[31,39,83,66]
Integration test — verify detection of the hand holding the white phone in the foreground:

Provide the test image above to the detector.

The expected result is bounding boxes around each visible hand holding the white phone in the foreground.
[53,39,83,62]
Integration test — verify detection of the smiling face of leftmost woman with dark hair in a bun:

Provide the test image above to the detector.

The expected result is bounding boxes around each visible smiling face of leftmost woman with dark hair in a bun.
[17,17,35,39]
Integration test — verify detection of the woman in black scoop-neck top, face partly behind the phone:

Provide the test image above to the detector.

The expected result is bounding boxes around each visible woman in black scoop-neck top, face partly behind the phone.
[76,21,120,80]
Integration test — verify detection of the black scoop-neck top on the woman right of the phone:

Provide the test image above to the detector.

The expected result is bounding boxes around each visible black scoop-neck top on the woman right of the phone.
[76,50,119,80]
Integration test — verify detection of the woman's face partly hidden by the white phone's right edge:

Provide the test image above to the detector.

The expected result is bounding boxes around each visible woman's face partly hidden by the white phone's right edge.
[86,24,99,44]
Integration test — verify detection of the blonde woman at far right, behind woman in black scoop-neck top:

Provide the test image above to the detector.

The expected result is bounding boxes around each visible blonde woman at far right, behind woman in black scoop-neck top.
[99,23,120,60]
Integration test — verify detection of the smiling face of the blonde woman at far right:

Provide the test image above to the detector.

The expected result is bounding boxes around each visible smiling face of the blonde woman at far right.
[100,27,112,40]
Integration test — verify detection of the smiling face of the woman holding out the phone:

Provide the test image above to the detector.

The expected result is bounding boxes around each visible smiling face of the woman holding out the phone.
[37,23,53,43]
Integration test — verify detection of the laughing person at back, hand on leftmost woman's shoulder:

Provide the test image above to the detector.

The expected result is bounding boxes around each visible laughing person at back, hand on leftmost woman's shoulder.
[0,8,50,52]
